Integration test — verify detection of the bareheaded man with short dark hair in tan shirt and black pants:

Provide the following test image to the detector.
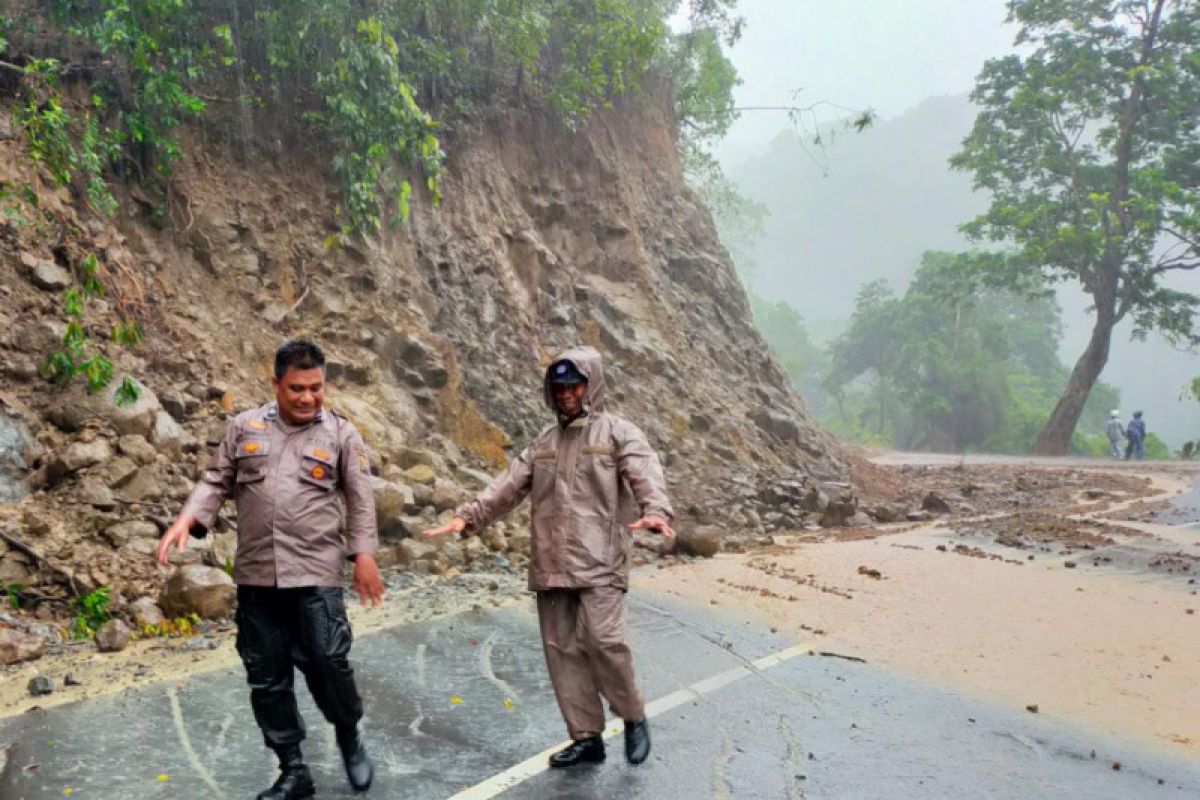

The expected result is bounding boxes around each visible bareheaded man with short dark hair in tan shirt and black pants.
[158,339,383,800]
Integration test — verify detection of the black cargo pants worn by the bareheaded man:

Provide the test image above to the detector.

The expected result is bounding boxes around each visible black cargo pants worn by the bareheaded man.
[236,585,362,750]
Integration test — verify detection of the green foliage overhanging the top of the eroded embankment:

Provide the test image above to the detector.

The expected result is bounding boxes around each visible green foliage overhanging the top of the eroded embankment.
[0,0,742,235]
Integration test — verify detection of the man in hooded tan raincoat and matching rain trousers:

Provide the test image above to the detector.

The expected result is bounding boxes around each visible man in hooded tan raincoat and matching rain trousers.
[425,347,674,766]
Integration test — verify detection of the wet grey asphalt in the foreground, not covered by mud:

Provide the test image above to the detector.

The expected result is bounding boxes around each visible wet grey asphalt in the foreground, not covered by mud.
[0,591,1200,800]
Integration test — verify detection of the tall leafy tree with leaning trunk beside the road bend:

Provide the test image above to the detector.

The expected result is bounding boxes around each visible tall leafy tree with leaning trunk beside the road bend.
[950,0,1200,455]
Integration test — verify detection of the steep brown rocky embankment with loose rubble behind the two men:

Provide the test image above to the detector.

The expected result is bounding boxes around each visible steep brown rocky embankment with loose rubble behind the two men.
[0,82,883,660]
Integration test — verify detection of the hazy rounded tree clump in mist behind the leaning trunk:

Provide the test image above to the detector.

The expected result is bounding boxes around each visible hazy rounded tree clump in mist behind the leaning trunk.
[822,252,1116,452]
